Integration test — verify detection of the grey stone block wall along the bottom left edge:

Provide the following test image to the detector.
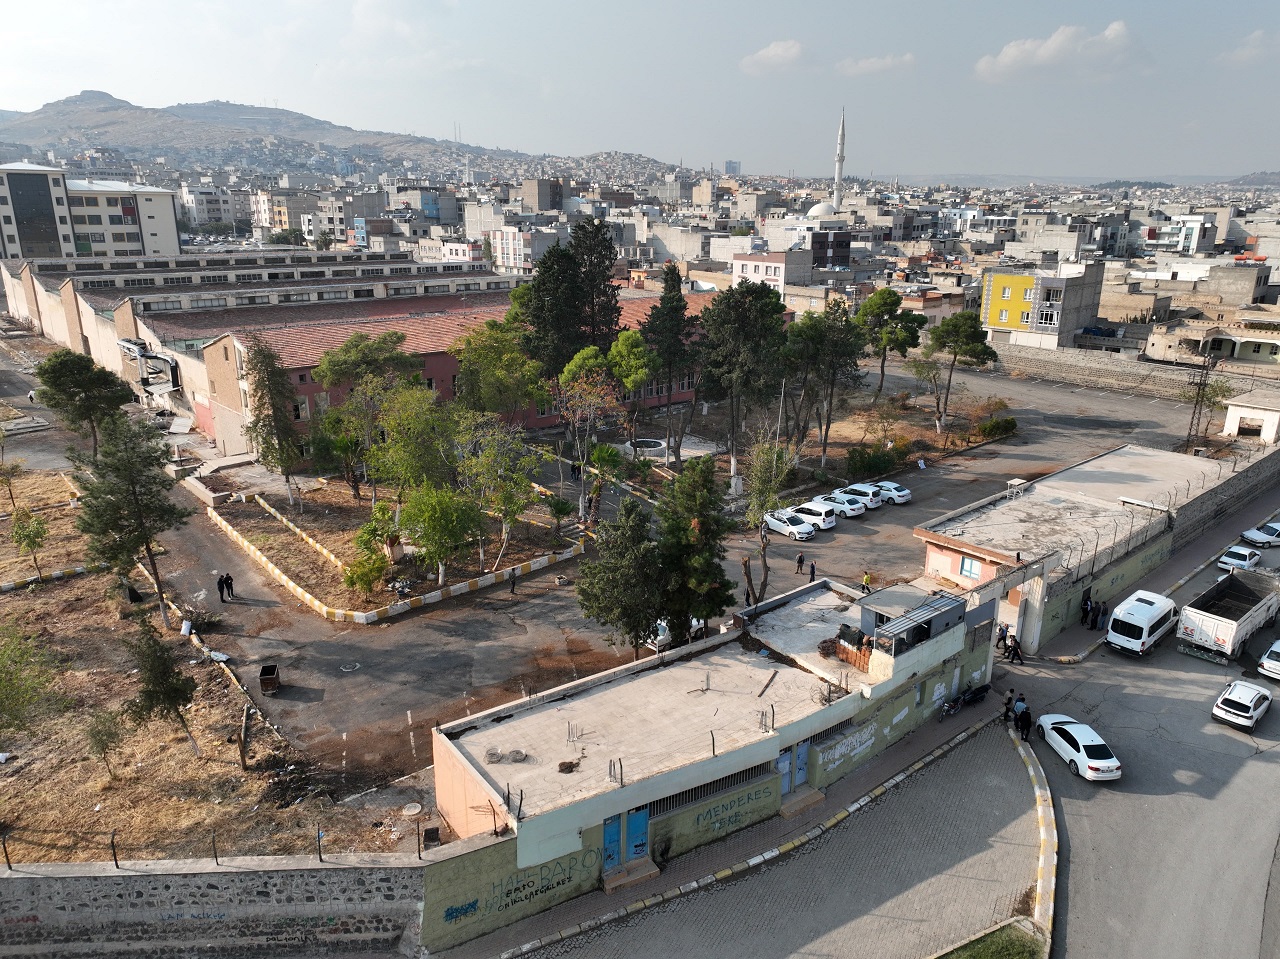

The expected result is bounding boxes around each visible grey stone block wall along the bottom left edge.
[0,857,425,959]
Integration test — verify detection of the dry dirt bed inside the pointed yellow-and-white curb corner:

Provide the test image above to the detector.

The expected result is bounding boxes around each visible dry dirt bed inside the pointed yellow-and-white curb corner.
[218,485,567,609]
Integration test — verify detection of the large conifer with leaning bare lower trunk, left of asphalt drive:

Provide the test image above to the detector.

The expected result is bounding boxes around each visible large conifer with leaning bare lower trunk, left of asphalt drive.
[73,416,192,626]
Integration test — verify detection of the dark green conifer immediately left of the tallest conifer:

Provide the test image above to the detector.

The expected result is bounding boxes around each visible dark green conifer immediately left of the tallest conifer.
[519,243,593,373]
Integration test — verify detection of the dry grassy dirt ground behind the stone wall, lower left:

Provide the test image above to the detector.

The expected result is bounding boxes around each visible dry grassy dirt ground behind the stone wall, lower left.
[0,574,399,862]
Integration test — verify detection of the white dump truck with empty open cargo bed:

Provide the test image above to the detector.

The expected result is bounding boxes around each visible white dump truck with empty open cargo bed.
[1178,570,1280,663]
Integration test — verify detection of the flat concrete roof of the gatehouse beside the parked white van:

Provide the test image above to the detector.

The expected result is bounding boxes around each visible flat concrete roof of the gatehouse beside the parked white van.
[920,446,1231,568]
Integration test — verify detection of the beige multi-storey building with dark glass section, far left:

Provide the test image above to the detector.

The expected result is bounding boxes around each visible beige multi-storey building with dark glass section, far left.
[0,163,179,260]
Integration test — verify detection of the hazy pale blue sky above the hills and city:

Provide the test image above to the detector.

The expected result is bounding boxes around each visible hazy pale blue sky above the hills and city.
[0,0,1280,181]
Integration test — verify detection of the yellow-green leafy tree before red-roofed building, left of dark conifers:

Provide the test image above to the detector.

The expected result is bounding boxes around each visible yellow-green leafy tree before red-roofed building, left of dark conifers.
[449,320,545,419]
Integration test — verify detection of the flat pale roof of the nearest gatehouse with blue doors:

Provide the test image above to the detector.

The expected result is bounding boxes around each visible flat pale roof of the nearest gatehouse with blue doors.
[453,635,836,816]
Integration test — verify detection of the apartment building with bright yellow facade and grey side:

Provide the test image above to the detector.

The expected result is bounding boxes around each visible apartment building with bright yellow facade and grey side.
[980,262,1103,350]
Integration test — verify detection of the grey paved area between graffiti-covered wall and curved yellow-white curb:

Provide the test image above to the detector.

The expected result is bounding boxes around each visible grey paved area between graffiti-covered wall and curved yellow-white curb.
[440,700,1039,959]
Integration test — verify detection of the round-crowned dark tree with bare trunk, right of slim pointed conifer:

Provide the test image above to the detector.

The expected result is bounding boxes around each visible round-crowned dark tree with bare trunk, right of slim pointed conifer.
[701,283,786,476]
